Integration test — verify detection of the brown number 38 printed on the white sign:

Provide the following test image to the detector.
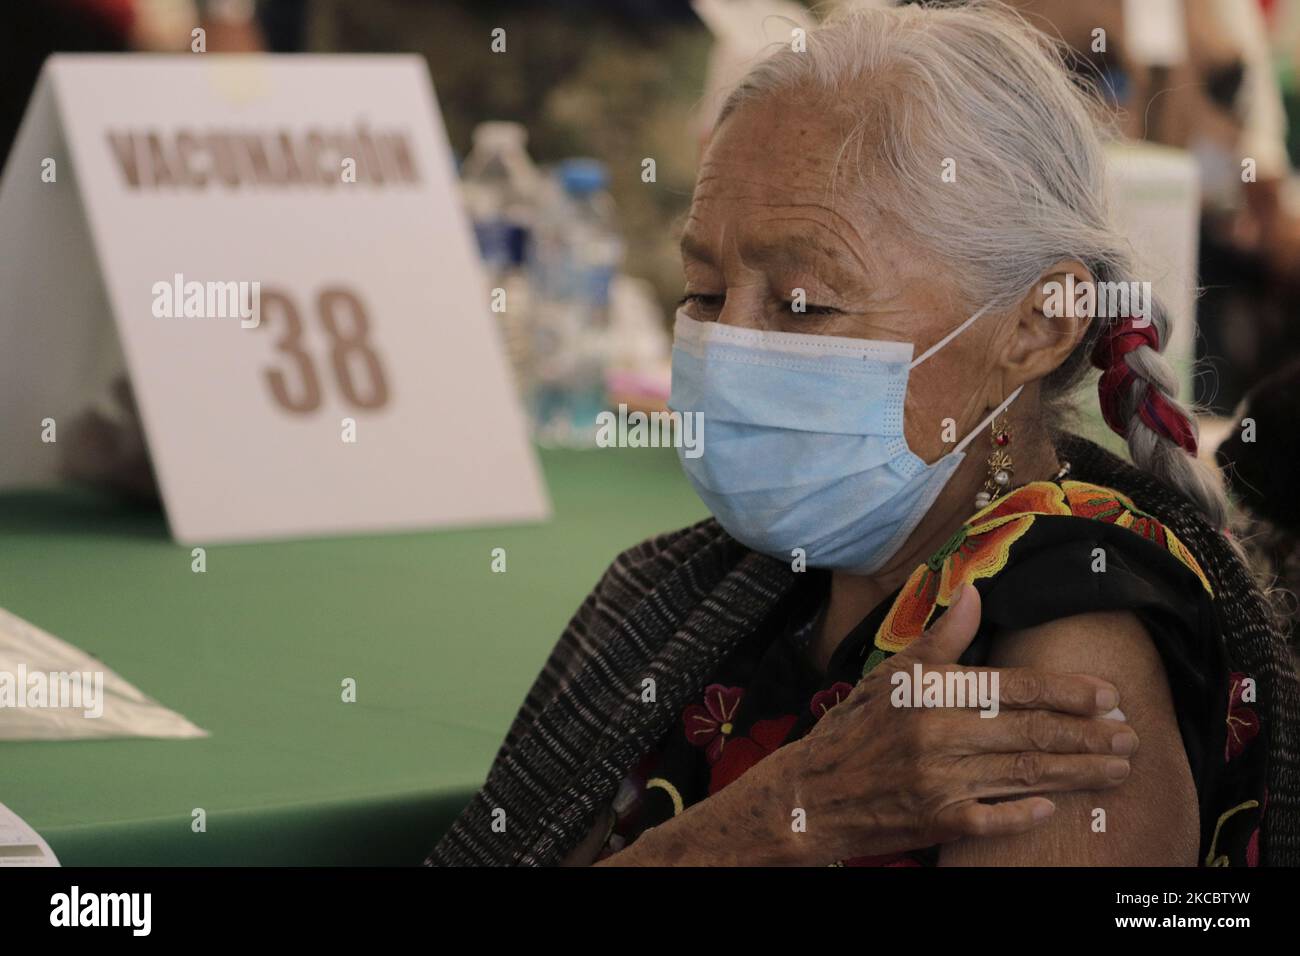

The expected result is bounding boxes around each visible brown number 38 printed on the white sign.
[260,287,389,415]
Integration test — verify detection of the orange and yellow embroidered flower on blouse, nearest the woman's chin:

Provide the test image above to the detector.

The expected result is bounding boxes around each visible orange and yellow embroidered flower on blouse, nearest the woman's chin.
[876,481,1070,653]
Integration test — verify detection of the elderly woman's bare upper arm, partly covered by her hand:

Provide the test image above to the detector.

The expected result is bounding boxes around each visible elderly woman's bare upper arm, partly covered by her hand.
[940,611,1200,866]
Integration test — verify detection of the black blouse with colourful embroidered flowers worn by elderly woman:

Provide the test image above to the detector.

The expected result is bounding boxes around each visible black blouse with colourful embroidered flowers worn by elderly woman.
[603,480,1266,866]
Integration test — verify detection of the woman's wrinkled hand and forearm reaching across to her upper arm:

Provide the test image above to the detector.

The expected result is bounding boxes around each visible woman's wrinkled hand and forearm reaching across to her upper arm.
[602,585,1138,866]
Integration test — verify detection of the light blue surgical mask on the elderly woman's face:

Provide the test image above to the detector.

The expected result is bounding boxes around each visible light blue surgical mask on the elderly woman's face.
[668,306,1023,574]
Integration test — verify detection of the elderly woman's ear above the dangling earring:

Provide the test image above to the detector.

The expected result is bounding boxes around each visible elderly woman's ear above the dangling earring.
[1001,259,1096,394]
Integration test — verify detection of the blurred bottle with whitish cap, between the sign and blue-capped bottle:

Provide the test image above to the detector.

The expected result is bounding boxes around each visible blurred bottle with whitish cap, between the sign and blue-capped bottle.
[460,122,542,394]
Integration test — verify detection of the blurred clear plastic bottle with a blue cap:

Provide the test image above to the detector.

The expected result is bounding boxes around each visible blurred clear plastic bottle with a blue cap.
[530,159,623,447]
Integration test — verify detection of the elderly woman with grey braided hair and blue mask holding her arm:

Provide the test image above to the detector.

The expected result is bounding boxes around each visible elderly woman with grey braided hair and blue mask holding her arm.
[429,1,1300,866]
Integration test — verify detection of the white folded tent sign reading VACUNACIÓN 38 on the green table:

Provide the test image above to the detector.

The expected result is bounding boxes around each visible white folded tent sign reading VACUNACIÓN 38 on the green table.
[0,55,549,544]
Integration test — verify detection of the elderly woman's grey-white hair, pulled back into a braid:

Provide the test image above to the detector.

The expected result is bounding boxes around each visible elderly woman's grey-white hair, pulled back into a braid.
[719,0,1226,527]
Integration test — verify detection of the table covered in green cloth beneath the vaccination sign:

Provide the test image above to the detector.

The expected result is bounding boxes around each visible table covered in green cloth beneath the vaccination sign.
[0,449,706,865]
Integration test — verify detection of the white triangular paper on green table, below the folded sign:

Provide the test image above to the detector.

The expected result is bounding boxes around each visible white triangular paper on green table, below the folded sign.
[0,607,208,740]
